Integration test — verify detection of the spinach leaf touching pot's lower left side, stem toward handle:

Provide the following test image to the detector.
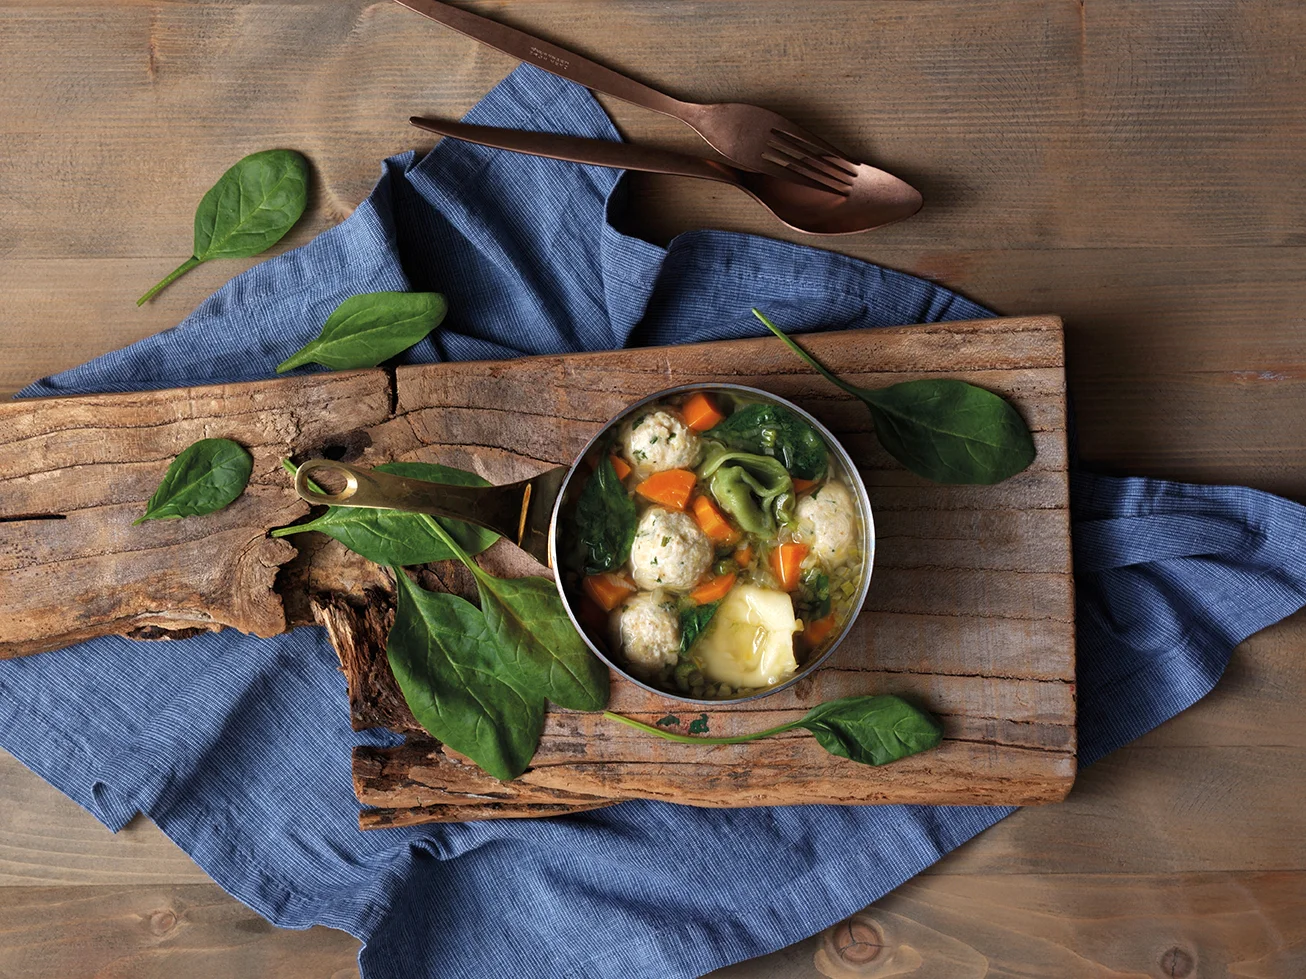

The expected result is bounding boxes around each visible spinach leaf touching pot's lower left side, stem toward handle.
[421,514,609,710]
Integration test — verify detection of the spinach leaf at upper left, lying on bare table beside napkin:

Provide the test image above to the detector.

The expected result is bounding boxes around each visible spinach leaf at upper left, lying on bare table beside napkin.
[136,150,308,305]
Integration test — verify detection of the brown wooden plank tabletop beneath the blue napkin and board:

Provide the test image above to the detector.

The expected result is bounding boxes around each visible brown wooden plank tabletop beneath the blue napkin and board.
[0,0,1306,979]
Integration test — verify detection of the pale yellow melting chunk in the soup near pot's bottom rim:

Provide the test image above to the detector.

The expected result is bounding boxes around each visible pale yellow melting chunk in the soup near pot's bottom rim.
[693,585,798,687]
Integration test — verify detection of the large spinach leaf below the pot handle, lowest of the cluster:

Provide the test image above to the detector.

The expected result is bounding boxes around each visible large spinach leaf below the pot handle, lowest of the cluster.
[385,568,545,779]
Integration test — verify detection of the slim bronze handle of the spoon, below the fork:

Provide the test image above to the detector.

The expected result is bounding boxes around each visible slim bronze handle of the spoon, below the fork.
[409,116,739,184]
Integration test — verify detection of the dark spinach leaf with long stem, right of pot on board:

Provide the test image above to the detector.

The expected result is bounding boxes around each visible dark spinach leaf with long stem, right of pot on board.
[752,309,1036,483]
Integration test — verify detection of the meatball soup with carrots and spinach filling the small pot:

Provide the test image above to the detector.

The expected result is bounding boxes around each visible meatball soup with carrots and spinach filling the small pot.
[567,392,865,698]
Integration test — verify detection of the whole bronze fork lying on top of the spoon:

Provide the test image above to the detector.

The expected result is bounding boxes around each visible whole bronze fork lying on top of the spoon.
[397,0,858,196]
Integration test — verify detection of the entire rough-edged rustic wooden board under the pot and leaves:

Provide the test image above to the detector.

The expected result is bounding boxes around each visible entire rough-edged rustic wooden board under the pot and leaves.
[0,317,1075,826]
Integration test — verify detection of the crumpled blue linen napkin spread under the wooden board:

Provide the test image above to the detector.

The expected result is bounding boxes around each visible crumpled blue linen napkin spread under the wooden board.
[10,68,1306,979]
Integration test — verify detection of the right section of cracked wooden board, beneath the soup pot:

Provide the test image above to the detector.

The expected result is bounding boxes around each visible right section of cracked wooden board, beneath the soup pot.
[368,319,1075,825]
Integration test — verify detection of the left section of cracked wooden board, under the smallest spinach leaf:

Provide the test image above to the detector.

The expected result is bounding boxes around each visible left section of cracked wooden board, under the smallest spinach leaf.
[0,372,389,657]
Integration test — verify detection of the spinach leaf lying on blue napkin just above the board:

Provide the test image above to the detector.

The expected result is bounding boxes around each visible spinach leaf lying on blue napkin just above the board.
[277,292,448,373]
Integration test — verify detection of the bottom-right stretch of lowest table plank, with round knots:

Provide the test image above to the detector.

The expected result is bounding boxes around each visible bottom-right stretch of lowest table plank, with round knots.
[741,872,1306,979]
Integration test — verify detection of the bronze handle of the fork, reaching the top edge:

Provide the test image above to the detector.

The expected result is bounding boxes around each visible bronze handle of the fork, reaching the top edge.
[397,0,691,120]
